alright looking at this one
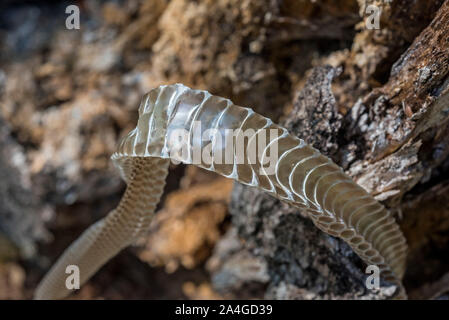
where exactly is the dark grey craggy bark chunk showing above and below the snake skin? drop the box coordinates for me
[206,66,394,299]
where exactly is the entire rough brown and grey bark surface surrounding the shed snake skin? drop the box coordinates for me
[0,0,449,299]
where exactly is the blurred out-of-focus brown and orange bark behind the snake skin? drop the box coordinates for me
[0,0,449,299]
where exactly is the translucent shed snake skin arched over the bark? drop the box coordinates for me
[35,84,407,299]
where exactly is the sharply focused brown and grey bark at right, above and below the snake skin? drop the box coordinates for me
[209,1,449,299]
